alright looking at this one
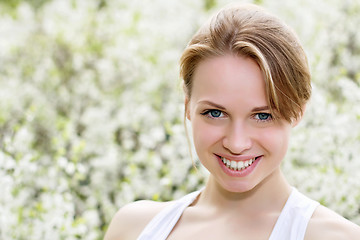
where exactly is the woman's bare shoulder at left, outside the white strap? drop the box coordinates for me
[104,200,171,240]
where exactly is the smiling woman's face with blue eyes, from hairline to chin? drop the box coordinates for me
[186,55,291,192]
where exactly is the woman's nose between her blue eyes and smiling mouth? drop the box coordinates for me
[223,122,252,155]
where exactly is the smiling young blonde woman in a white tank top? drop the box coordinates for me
[105,5,360,240]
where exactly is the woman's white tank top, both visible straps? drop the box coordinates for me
[137,188,319,240]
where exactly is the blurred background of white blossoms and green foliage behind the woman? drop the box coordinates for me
[0,0,360,240]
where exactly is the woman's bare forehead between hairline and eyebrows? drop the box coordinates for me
[191,55,267,109]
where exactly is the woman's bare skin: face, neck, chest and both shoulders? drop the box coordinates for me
[105,55,360,240]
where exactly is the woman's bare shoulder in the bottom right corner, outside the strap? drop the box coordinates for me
[305,205,360,240]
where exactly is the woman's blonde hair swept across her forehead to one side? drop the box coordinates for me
[180,4,311,122]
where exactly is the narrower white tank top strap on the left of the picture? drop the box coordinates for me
[137,190,201,240]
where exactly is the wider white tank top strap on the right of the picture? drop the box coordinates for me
[269,188,319,240]
